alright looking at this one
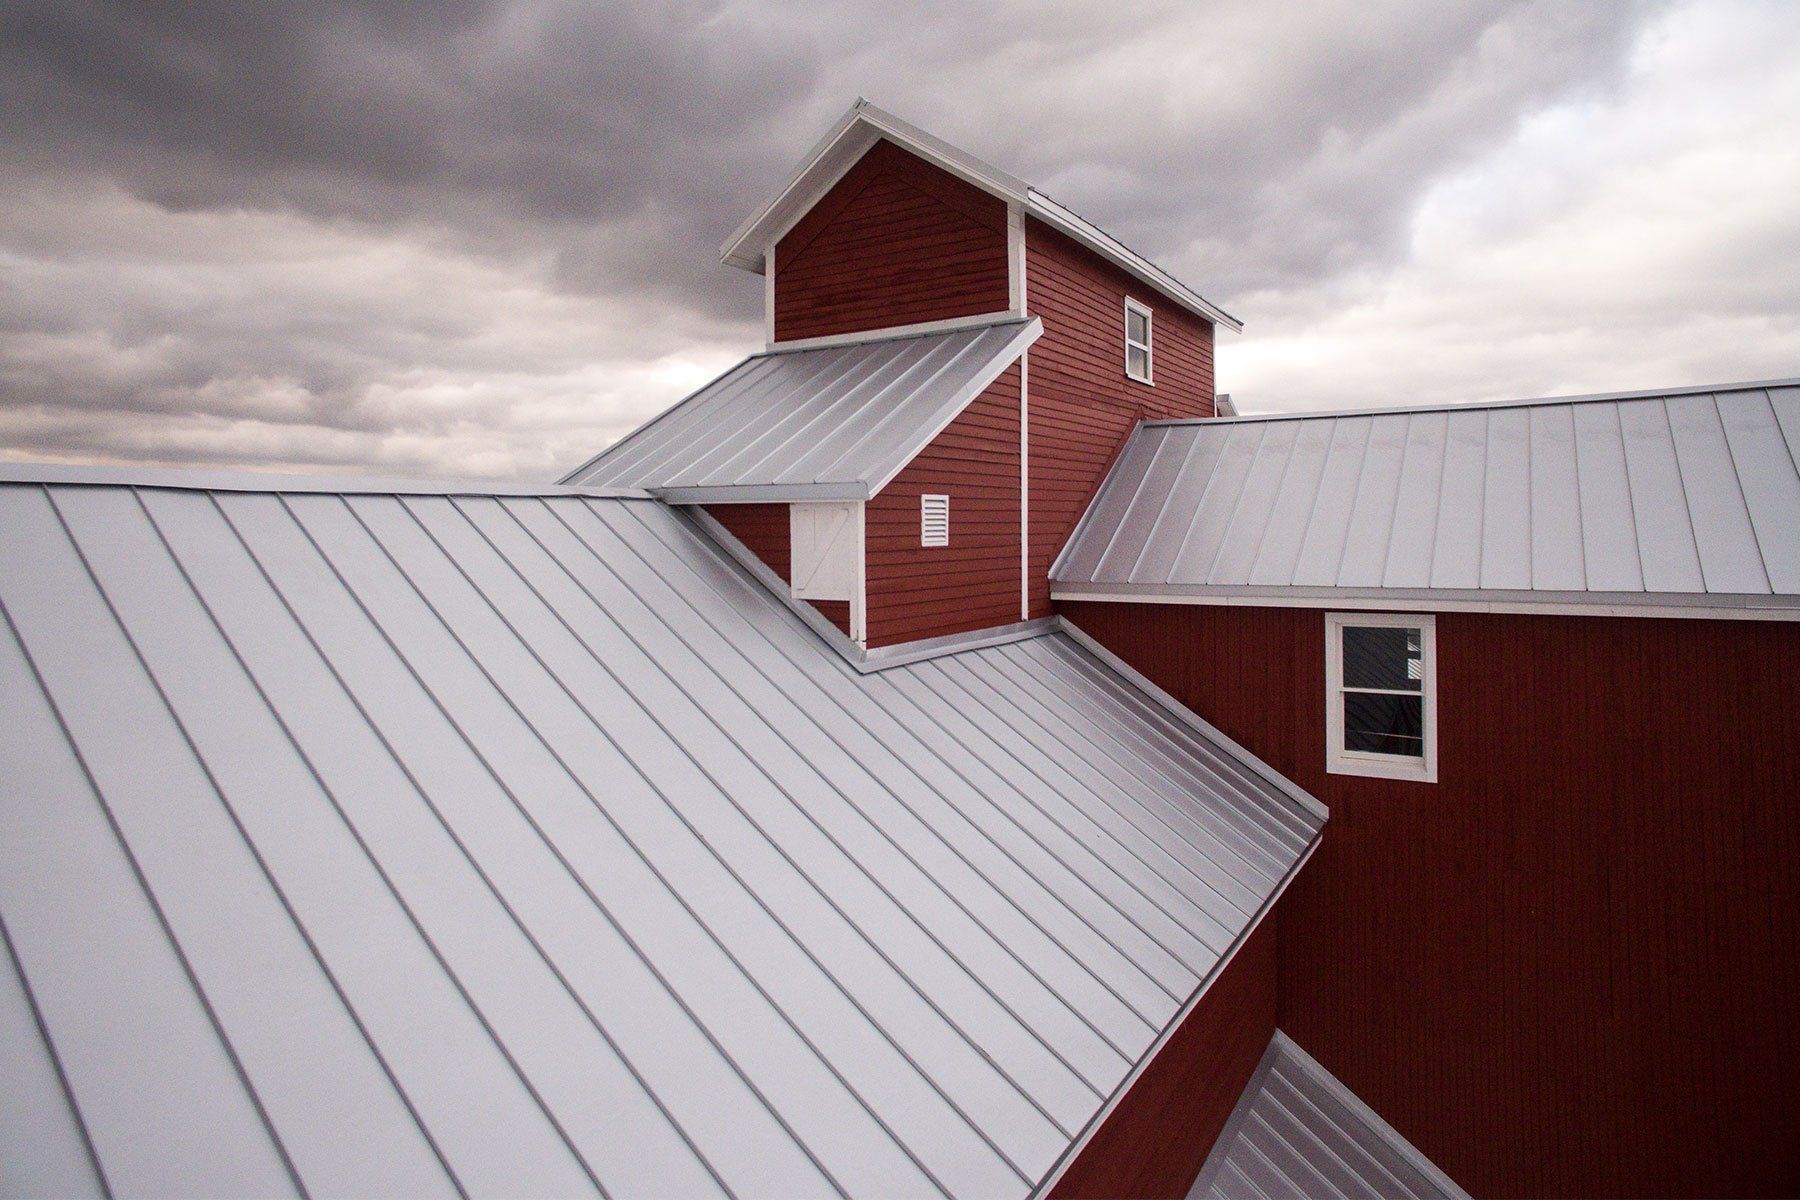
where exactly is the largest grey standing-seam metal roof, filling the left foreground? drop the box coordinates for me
[0,468,1321,1196]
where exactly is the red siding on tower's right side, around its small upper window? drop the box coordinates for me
[1024,218,1213,617]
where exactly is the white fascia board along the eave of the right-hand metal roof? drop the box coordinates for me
[1049,583,1800,621]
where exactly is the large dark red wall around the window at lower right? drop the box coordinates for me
[1060,603,1800,1196]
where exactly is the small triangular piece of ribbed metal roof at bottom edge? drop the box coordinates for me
[1188,1031,1469,1200]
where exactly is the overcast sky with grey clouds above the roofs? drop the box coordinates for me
[0,0,1800,479]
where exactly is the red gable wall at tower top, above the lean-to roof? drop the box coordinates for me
[774,140,1006,340]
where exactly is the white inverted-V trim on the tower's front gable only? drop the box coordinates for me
[718,99,1030,273]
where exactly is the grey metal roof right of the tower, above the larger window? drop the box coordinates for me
[1051,380,1800,612]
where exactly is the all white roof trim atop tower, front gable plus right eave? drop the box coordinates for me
[718,97,1244,333]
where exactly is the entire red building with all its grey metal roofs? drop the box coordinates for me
[0,103,1800,1200]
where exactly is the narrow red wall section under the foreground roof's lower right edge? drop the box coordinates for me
[1051,919,1276,1200]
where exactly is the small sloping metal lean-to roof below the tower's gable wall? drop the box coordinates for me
[563,317,1044,504]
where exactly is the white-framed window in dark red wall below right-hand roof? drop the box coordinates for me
[1325,612,1438,783]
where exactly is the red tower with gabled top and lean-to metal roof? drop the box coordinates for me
[567,101,1242,649]
